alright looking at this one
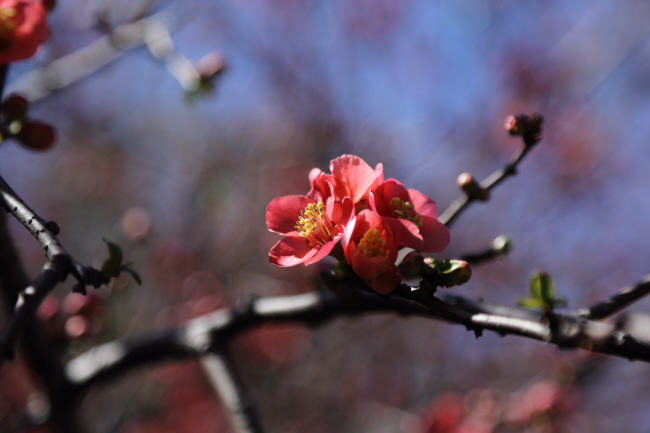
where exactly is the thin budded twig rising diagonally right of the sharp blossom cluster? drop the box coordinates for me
[438,113,544,227]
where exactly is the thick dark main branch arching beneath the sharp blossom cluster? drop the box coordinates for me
[67,274,650,388]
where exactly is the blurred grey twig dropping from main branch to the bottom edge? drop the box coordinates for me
[200,345,264,433]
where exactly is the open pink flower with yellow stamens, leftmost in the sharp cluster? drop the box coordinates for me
[266,195,354,267]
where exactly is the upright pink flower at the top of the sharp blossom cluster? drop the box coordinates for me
[307,155,384,212]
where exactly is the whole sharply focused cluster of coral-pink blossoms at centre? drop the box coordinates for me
[266,155,449,293]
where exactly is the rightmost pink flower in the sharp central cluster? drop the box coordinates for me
[370,179,449,253]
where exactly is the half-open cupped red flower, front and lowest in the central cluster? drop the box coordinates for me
[342,209,401,291]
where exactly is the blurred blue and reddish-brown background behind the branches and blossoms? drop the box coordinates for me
[0,0,650,433]
